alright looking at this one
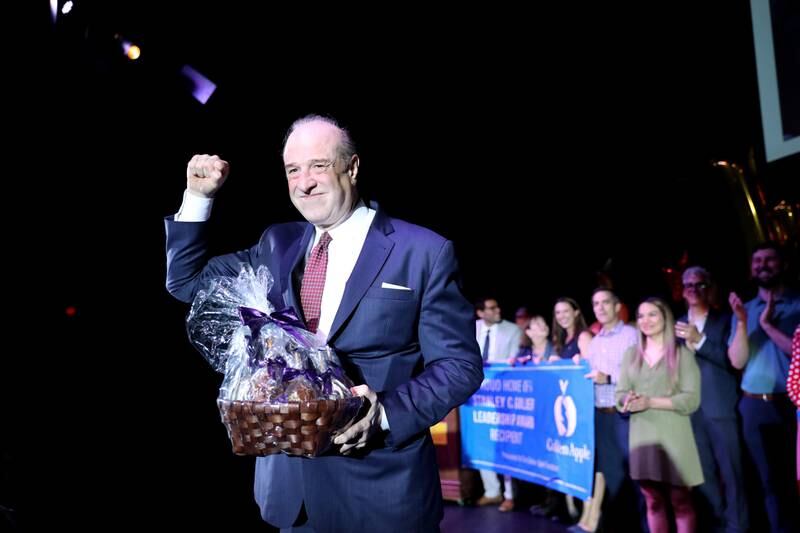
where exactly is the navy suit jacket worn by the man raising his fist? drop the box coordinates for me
[165,202,483,532]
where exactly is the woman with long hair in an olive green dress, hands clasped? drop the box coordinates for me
[616,298,703,533]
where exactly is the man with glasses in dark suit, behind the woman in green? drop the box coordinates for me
[675,266,748,532]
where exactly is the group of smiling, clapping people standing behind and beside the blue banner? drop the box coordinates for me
[476,243,800,533]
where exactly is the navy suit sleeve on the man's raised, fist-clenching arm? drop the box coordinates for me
[164,217,266,302]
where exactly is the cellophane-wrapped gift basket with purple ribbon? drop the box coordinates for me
[186,264,363,457]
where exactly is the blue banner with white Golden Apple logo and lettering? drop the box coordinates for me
[459,360,594,499]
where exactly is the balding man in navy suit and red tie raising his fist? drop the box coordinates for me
[166,116,483,533]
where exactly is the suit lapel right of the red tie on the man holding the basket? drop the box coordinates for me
[328,210,394,343]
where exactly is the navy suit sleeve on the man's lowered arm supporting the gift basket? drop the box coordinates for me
[378,241,483,448]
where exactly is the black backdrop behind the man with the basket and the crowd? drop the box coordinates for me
[0,1,800,527]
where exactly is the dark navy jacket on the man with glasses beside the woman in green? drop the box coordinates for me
[680,309,739,419]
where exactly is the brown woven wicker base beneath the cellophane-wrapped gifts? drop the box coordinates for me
[217,396,364,457]
